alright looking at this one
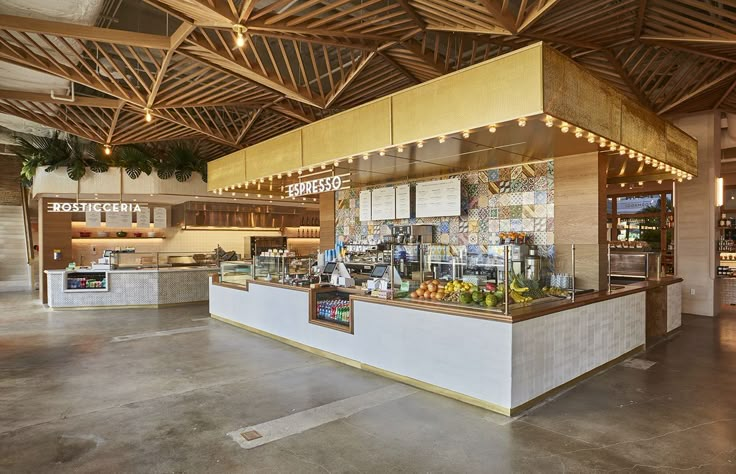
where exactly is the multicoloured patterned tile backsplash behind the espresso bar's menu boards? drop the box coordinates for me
[335,161,554,251]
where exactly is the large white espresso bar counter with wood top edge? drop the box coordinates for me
[210,275,681,415]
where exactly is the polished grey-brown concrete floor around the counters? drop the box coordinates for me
[0,294,736,473]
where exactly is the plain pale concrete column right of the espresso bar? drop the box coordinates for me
[674,112,721,316]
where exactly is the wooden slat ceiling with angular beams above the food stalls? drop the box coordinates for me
[0,0,736,158]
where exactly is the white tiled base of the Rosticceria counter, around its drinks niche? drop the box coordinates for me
[46,268,210,308]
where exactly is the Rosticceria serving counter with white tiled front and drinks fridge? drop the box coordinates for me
[45,266,218,309]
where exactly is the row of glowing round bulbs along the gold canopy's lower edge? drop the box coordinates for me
[213,115,693,194]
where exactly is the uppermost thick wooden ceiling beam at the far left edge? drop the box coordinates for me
[0,15,171,49]
